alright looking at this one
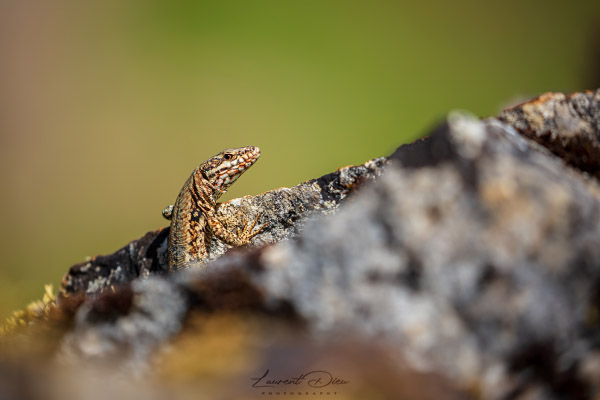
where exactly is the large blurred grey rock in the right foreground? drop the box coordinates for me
[169,111,600,398]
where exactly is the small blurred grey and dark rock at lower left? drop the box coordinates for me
[58,278,186,374]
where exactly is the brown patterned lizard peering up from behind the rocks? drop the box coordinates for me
[162,146,267,272]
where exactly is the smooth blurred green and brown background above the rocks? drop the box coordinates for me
[0,0,600,317]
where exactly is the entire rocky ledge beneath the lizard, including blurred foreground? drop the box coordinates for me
[0,90,600,399]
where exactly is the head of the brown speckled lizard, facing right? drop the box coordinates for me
[199,146,260,193]
